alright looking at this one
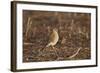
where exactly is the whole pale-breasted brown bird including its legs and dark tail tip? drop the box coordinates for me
[39,28,59,56]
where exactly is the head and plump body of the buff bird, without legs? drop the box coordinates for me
[46,28,59,48]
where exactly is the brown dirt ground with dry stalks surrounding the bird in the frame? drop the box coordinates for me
[23,10,91,62]
